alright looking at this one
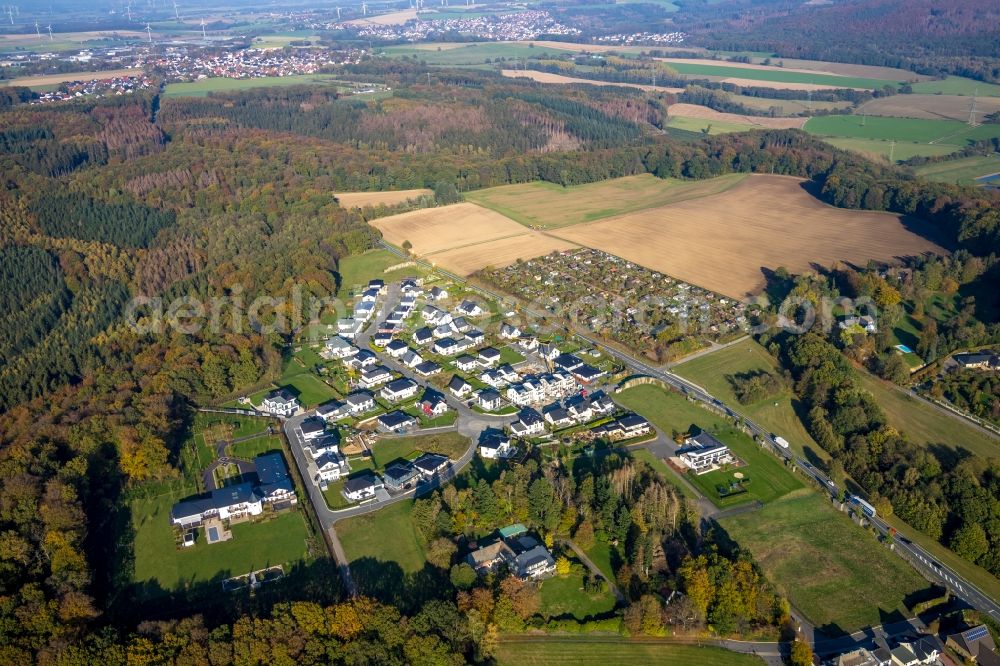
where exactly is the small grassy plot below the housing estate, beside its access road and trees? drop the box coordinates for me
[337,500,427,573]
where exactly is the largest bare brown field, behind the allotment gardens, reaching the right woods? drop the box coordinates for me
[548,175,945,298]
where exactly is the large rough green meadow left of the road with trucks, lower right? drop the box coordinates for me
[721,489,928,633]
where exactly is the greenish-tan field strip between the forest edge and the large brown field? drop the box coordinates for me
[465,174,745,229]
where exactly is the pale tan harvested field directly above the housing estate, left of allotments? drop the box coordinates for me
[372,203,576,275]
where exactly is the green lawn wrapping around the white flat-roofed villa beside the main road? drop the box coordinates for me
[616,384,802,508]
